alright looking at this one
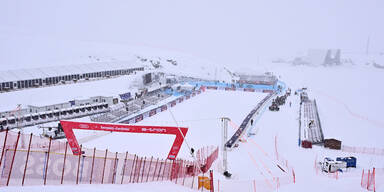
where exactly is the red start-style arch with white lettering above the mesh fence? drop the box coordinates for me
[60,121,188,160]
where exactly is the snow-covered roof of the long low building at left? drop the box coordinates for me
[0,60,142,82]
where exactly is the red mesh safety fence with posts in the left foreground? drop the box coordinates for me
[0,131,218,188]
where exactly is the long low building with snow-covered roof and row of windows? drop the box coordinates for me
[0,60,144,92]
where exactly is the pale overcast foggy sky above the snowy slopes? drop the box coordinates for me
[0,0,384,68]
